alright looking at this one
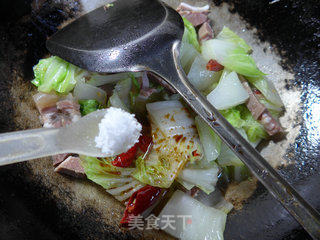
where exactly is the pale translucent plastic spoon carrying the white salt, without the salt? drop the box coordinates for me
[0,110,106,166]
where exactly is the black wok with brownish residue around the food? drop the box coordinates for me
[0,0,320,240]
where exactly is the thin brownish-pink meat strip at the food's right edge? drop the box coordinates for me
[242,81,283,136]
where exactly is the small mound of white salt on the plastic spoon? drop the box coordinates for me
[95,107,142,157]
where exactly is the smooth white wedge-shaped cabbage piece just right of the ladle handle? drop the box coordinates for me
[207,72,249,110]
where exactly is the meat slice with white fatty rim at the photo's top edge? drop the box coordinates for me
[177,2,209,27]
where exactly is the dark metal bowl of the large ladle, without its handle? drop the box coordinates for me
[47,0,184,73]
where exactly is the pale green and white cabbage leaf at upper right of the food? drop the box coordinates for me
[201,27,265,77]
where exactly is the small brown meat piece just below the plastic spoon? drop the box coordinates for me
[54,156,86,178]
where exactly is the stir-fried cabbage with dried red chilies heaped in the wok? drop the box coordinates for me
[32,1,283,235]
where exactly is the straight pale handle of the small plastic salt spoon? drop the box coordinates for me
[0,128,61,166]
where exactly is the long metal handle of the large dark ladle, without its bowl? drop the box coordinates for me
[157,43,320,239]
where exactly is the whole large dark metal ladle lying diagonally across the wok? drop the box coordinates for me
[47,0,320,236]
